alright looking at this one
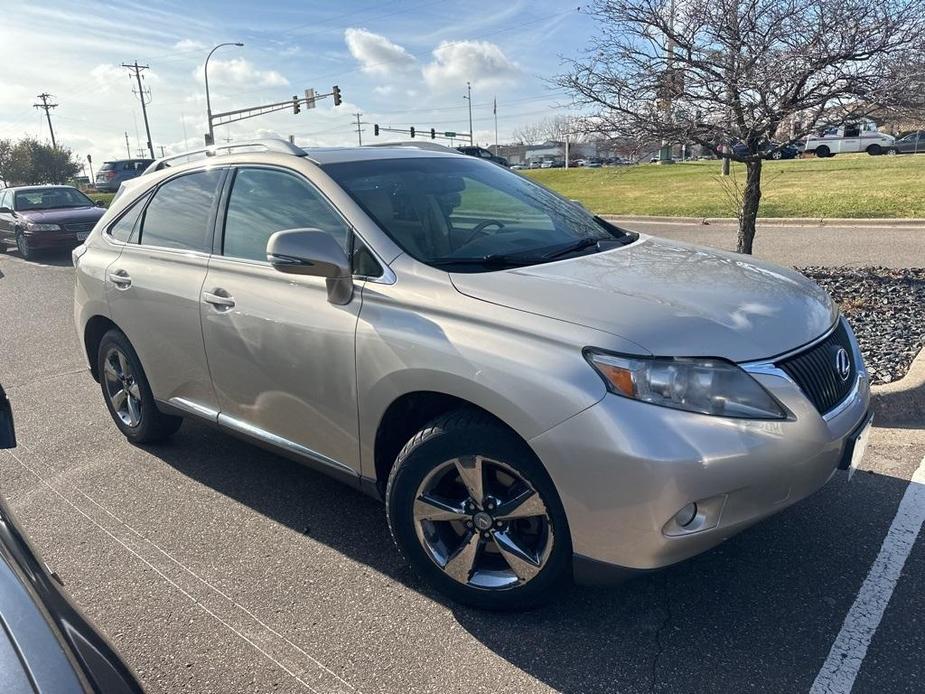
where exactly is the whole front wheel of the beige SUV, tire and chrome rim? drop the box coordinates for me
[386,408,572,610]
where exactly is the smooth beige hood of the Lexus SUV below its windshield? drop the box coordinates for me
[451,235,837,362]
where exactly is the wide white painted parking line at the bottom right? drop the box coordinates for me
[810,458,925,694]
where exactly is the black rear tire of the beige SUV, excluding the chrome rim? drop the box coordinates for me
[96,329,183,444]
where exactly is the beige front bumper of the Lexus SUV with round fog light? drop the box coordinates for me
[530,355,870,583]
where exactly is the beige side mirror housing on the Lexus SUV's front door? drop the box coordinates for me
[267,229,353,304]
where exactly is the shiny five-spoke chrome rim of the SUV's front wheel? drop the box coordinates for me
[413,455,555,589]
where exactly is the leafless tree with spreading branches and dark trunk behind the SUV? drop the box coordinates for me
[556,0,925,253]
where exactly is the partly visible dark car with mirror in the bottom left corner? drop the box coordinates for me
[0,386,142,694]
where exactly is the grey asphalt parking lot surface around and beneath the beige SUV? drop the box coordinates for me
[0,255,925,694]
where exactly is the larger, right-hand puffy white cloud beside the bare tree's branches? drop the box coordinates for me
[423,41,520,90]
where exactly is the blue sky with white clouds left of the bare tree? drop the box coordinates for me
[0,0,594,169]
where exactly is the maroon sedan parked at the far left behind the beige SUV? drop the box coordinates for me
[0,186,105,260]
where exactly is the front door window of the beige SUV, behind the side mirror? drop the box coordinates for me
[222,168,349,262]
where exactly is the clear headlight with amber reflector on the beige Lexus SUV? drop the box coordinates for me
[585,350,787,419]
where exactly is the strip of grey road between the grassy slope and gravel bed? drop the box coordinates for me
[616,219,925,268]
